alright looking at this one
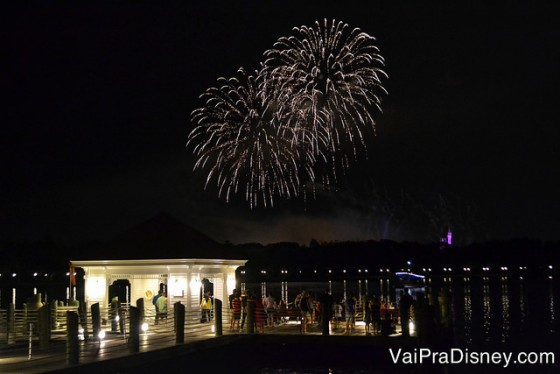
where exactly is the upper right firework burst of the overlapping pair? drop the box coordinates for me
[263,20,386,164]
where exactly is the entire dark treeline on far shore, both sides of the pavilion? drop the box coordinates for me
[0,239,560,281]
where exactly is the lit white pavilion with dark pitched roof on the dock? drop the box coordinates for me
[71,213,247,318]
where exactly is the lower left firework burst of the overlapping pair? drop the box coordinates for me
[187,69,313,208]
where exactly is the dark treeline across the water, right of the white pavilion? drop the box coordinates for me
[230,239,560,276]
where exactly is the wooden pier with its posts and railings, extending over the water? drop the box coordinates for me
[0,303,415,373]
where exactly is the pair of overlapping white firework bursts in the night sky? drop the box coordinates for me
[187,20,386,207]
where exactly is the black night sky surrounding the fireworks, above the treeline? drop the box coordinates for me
[0,1,560,243]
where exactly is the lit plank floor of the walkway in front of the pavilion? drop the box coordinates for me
[0,321,404,374]
